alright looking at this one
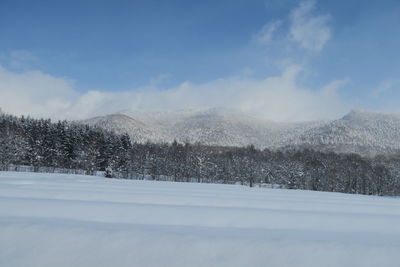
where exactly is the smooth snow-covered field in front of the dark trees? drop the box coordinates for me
[0,172,400,267]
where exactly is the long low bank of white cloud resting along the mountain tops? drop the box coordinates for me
[0,65,348,121]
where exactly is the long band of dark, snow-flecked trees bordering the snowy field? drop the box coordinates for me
[0,114,400,195]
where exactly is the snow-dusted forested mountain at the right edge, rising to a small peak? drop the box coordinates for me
[288,110,400,155]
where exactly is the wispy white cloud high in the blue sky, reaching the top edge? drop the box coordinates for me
[289,0,331,52]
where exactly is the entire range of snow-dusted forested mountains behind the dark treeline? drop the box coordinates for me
[83,108,400,155]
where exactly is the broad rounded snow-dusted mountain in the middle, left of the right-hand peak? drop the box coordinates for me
[83,108,309,147]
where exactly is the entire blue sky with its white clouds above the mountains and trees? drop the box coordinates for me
[0,0,400,121]
